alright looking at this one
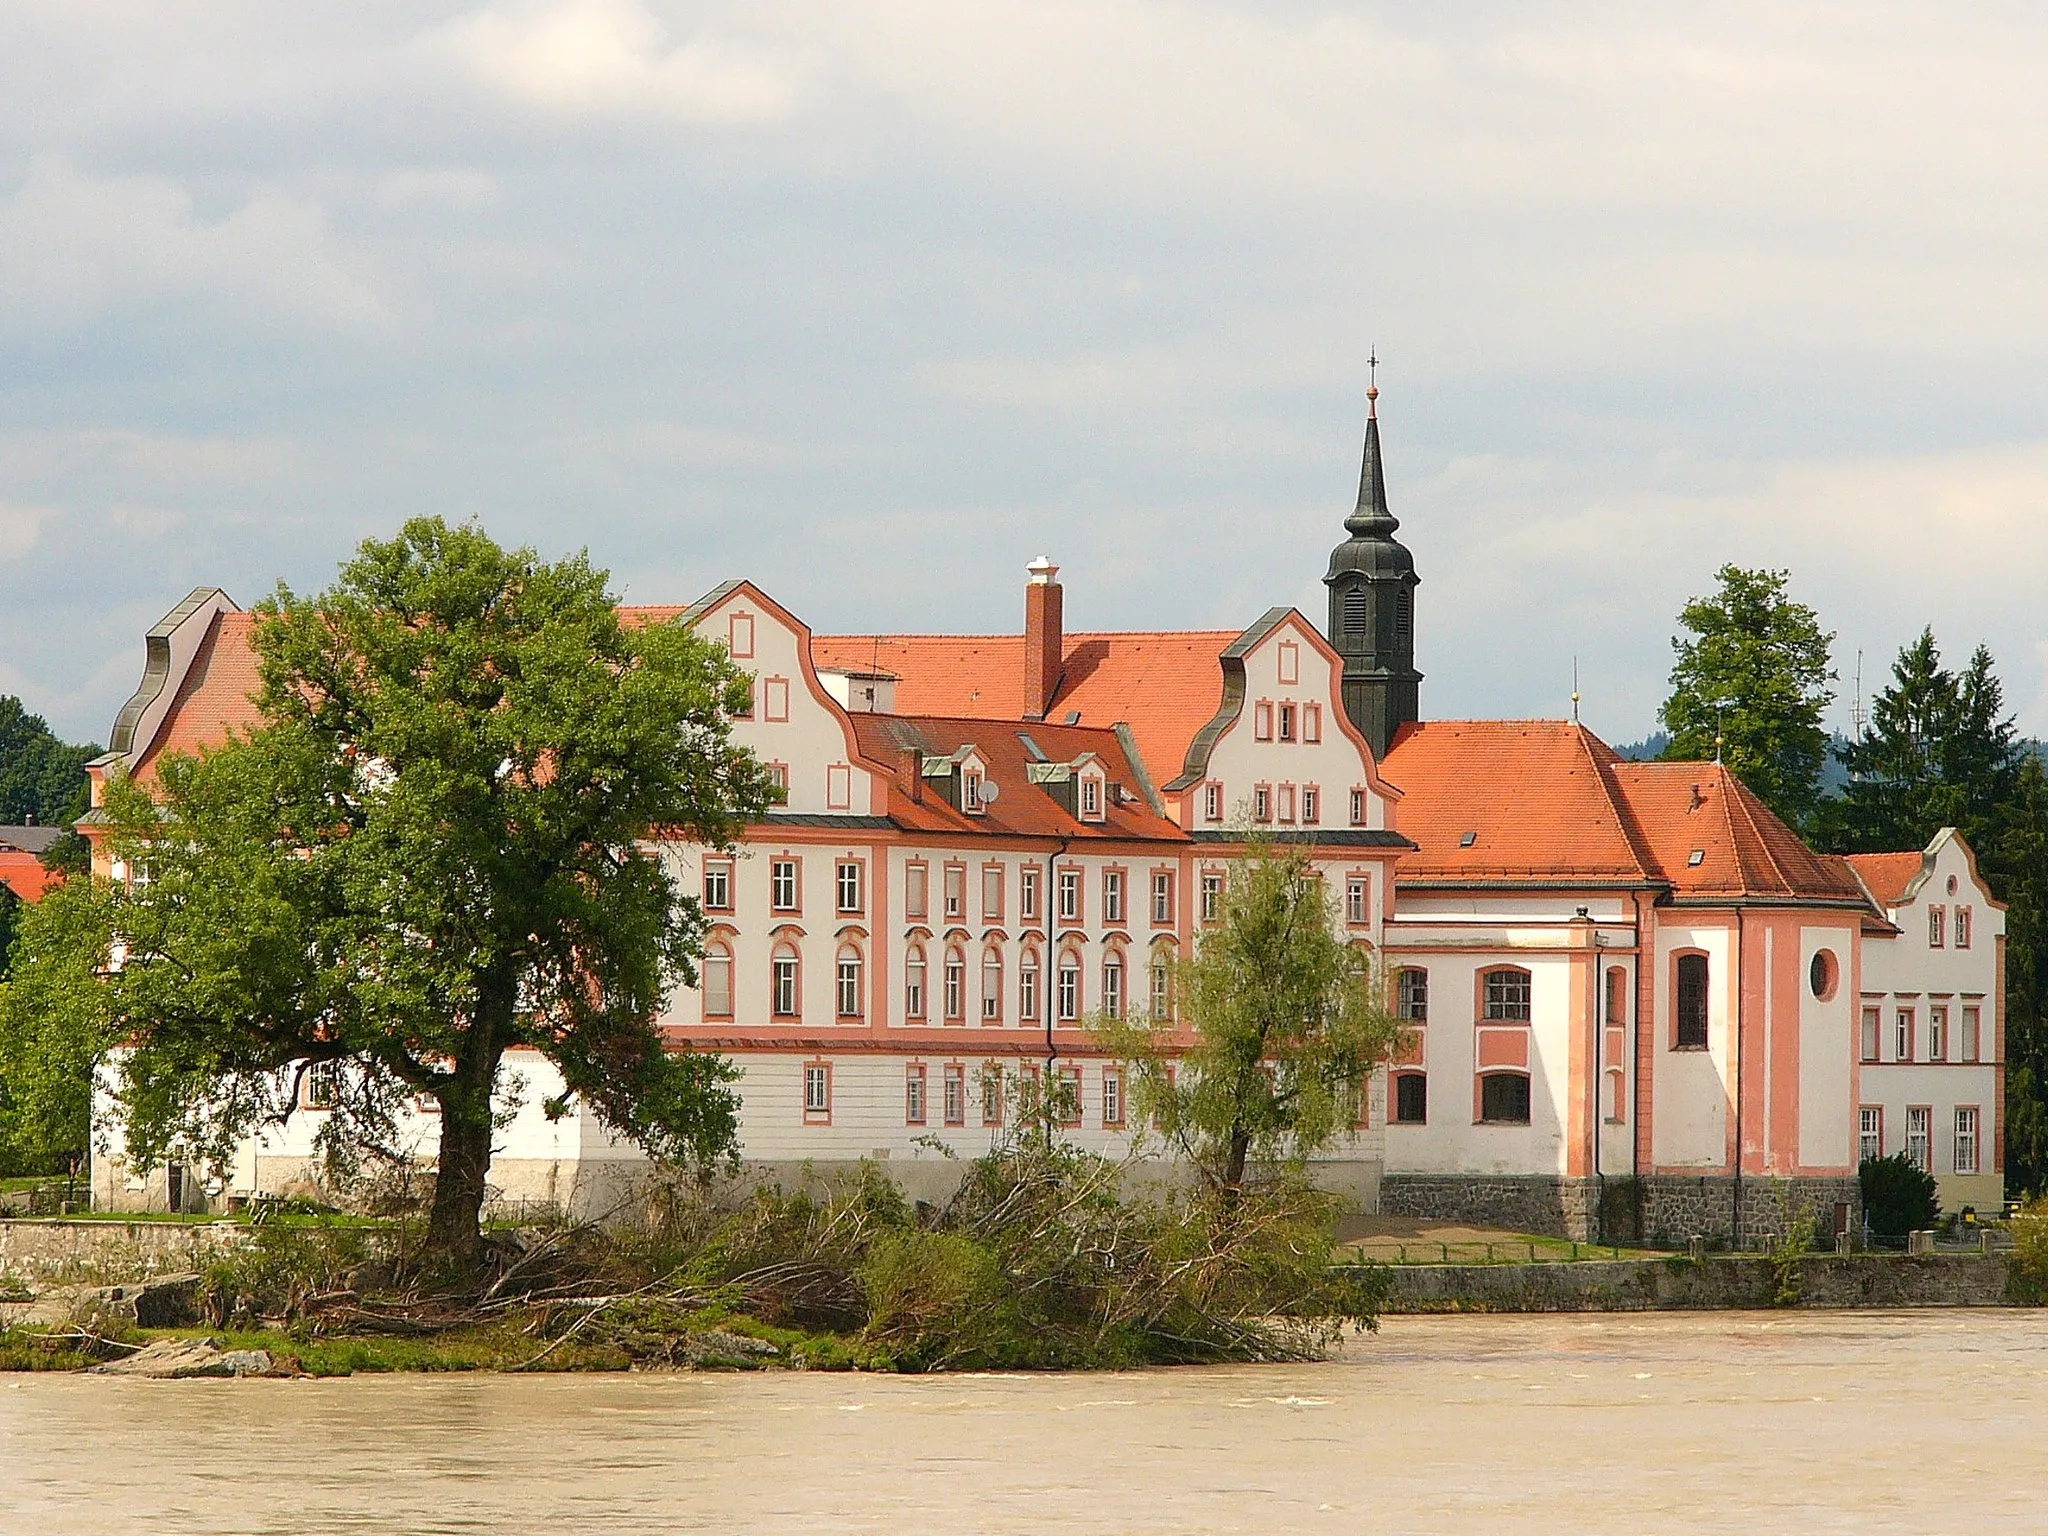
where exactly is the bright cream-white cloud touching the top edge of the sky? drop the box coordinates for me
[428,0,801,123]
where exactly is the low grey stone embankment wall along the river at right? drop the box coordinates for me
[1386,1253,2007,1313]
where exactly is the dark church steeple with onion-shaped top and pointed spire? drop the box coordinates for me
[1323,385,1421,758]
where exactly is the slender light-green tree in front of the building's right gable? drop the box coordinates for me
[1094,840,1405,1194]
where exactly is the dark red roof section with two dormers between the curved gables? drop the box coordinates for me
[850,713,1188,844]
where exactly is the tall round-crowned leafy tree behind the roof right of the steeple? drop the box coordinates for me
[1661,565,1835,825]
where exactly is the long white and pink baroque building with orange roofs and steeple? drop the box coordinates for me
[92,412,2003,1241]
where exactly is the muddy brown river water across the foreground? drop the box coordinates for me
[0,1311,2048,1536]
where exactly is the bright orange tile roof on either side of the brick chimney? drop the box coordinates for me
[811,629,1237,784]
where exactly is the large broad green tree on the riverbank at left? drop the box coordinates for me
[14,520,774,1268]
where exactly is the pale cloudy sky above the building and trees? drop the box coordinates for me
[0,0,2048,741]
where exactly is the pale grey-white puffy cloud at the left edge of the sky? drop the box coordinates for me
[0,154,383,334]
